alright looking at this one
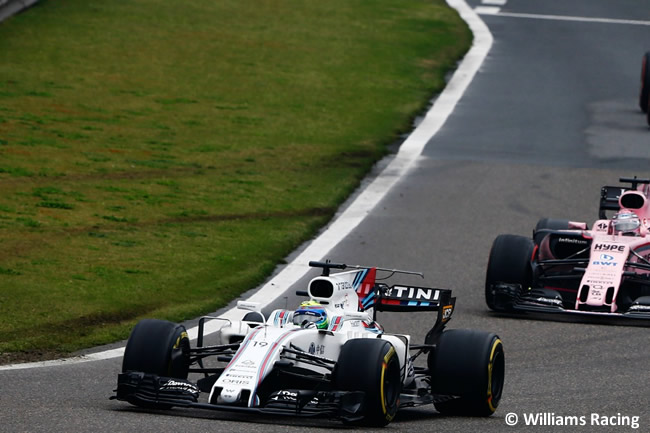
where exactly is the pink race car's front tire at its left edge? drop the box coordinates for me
[485,235,534,311]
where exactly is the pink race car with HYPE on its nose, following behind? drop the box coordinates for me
[485,177,650,319]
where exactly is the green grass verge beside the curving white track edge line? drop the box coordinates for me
[0,0,471,360]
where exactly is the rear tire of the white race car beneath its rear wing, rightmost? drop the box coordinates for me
[428,329,505,416]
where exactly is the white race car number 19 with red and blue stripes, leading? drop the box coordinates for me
[111,262,505,426]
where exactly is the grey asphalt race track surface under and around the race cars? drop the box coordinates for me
[0,0,650,433]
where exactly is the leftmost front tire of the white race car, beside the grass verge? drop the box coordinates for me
[122,319,190,379]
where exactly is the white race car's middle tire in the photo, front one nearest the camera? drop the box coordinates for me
[333,338,402,427]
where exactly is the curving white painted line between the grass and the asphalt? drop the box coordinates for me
[0,0,493,371]
